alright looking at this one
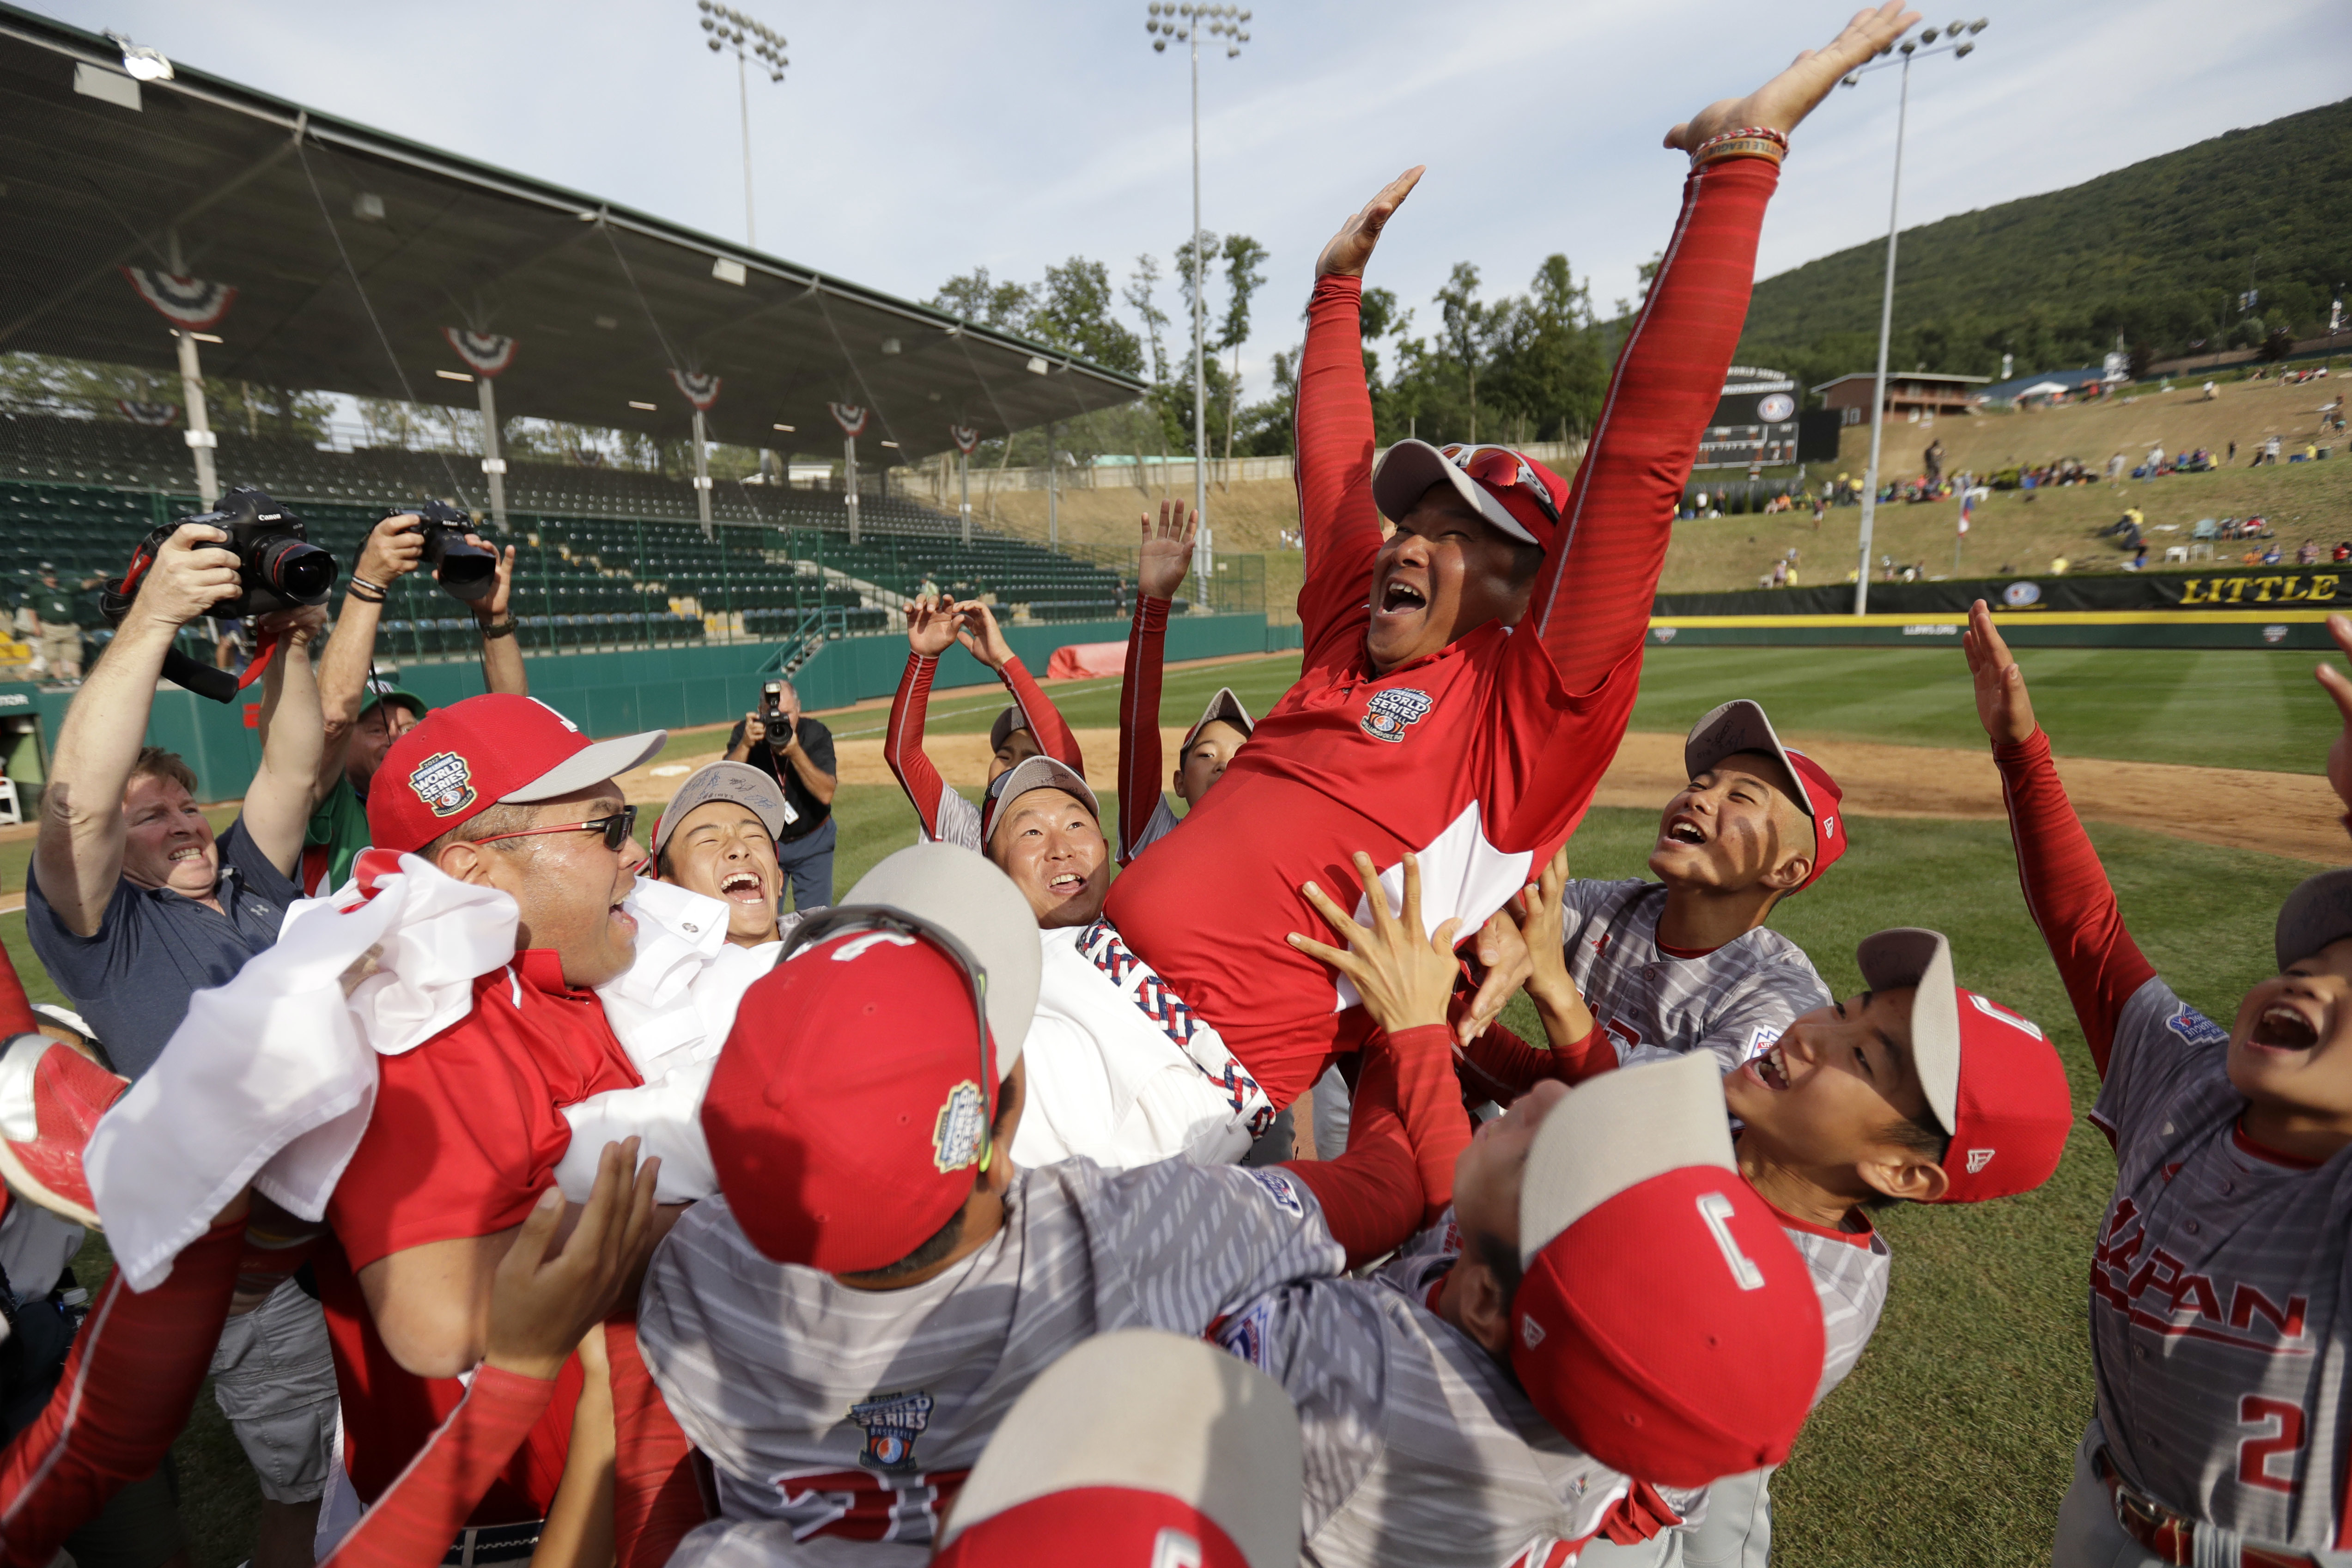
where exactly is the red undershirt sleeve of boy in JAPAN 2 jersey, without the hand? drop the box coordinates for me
[1992,729,2157,1077]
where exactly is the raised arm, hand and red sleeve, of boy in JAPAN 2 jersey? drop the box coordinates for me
[1962,600,2157,1077]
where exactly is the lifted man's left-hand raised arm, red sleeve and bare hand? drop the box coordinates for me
[1296,167,1421,668]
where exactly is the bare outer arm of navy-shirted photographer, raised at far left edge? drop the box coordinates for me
[33,522,240,936]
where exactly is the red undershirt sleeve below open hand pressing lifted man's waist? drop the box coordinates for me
[1282,1022,1470,1270]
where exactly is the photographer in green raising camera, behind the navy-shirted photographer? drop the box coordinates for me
[301,512,532,893]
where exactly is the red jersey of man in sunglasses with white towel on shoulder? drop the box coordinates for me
[317,948,642,1523]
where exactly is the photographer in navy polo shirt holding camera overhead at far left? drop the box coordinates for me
[24,524,336,1568]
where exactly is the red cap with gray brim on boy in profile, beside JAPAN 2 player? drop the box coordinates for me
[1854,926,2074,1203]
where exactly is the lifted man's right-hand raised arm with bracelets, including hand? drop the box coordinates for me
[1522,0,1917,703]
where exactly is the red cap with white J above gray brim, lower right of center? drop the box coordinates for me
[1510,1051,1825,1486]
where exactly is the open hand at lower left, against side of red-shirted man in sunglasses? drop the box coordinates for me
[485,1138,661,1378]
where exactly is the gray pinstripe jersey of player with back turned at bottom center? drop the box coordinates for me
[638,1159,1345,1544]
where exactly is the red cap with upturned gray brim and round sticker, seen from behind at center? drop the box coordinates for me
[701,844,1042,1274]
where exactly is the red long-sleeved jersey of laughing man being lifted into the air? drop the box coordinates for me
[1108,160,1778,1105]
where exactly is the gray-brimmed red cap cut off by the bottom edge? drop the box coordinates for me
[931,1328,1303,1568]
